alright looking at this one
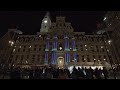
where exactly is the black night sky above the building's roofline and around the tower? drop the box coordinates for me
[0,11,106,36]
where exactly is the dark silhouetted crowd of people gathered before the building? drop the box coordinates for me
[0,66,117,79]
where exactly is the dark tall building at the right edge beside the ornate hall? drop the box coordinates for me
[104,11,120,64]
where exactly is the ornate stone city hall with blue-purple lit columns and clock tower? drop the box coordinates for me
[0,13,115,68]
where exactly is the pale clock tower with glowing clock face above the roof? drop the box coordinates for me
[40,12,51,32]
